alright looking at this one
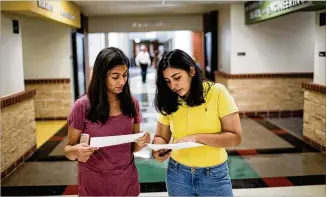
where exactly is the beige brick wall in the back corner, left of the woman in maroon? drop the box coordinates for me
[25,83,72,118]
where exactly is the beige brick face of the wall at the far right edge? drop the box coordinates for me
[303,90,326,146]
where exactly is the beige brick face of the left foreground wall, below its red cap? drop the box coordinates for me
[0,98,36,172]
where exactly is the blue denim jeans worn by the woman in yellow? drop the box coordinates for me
[166,158,233,196]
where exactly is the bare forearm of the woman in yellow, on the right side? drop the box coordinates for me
[196,131,242,148]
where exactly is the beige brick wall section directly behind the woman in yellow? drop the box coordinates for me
[216,76,312,112]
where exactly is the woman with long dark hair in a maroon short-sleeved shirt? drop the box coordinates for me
[65,47,150,196]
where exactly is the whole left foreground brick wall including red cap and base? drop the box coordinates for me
[0,90,36,180]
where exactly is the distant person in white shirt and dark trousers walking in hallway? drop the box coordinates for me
[135,45,151,83]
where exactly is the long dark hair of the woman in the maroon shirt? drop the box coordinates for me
[87,47,136,124]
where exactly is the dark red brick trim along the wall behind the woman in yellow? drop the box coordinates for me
[215,71,313,79]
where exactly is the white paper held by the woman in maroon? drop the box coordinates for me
[90,132,145,148]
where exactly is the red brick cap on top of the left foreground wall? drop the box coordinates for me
[0,90,36,109]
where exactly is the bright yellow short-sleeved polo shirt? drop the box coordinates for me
[158,83,238,167]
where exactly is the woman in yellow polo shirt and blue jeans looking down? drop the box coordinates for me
[152,49,242,196]
